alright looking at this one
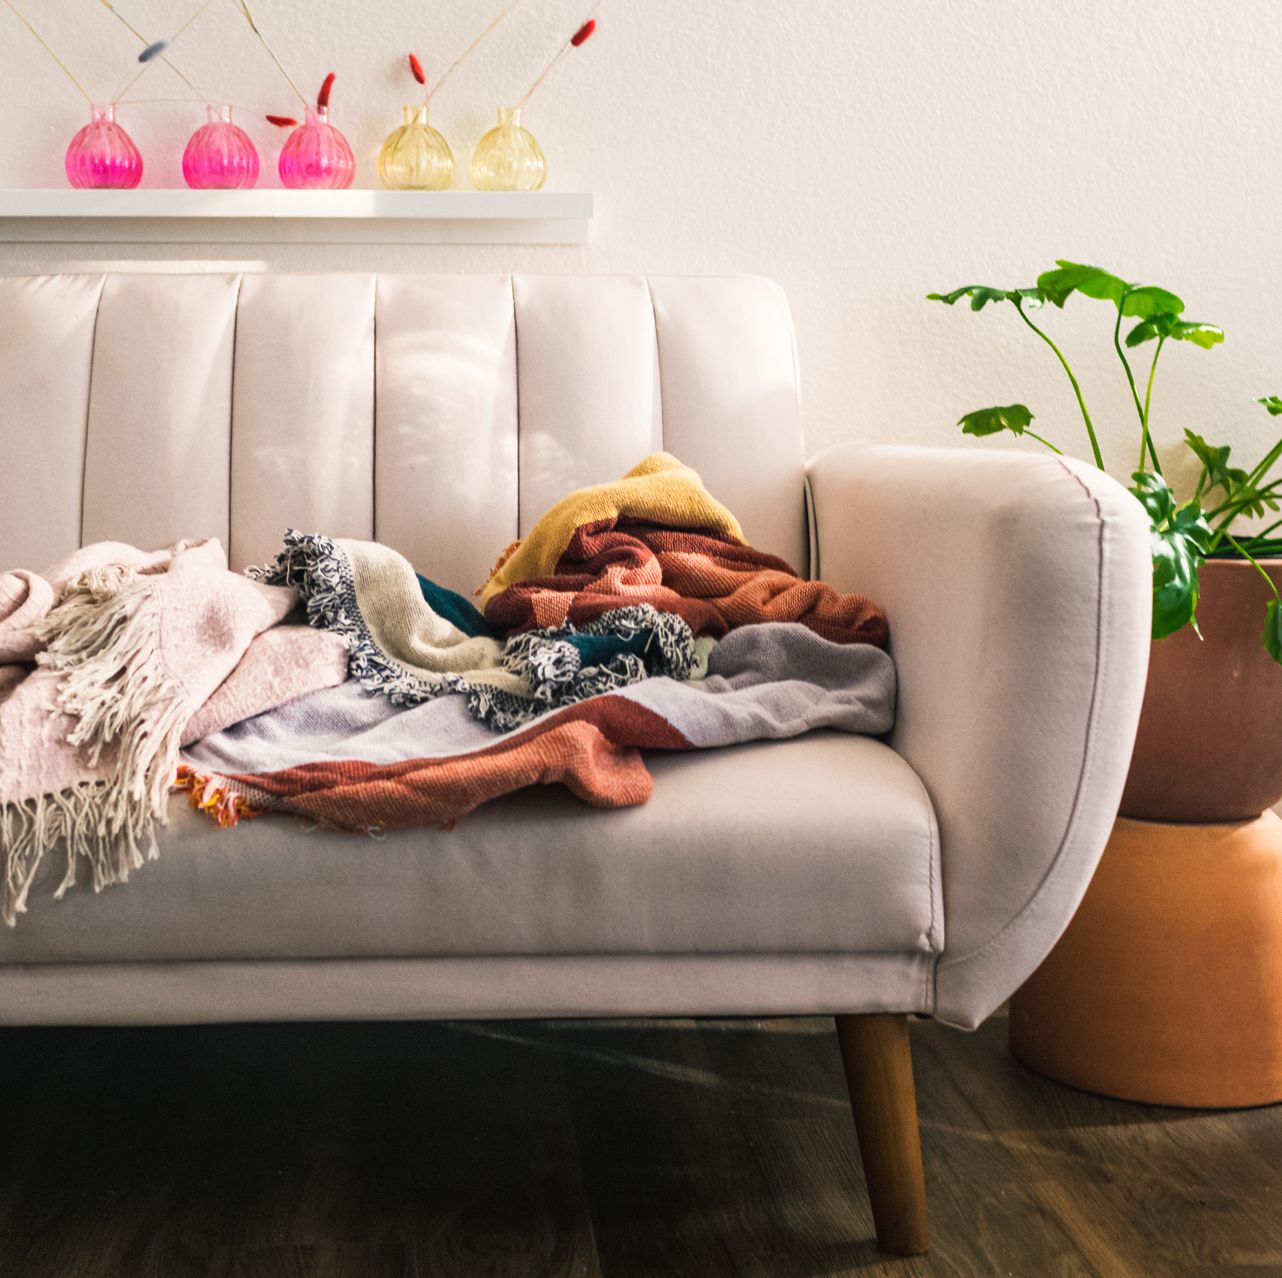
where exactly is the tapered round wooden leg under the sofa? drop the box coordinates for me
[837,1015,927,1256]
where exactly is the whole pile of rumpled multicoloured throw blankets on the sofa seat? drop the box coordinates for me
[0,454,895,925]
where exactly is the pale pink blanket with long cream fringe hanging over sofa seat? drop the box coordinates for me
[0,541,346,927]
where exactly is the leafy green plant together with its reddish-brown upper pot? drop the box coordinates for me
[929,260,1282,822]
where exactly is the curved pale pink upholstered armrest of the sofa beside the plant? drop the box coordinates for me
[808,445,1151,1027]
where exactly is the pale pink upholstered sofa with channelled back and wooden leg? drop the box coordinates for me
[0,274,1149,1251]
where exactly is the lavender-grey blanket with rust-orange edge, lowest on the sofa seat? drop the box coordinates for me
[183,623,895,829]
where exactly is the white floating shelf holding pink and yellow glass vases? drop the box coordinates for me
[0,188,592,244]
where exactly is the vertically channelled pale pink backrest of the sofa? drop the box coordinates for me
[0,273,808,590]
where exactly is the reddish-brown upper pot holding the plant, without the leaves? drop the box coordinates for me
[1122,559,1282,822]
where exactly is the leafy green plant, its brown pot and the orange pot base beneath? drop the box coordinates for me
[931,261,1282,1108]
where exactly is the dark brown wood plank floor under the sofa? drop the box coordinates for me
[0,1020,1282,1278]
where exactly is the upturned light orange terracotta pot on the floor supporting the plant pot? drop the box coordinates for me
[1010,813,1282,1109]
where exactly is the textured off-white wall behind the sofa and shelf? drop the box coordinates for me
[0,0,1282,484]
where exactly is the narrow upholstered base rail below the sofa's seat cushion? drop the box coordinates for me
[0,952,935,1025]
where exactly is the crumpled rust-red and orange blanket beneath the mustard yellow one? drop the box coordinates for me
[485,518,888,647]
